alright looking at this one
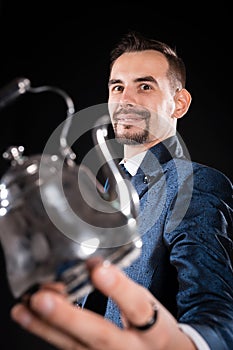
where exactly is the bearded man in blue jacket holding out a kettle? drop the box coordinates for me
[12,33,233,350]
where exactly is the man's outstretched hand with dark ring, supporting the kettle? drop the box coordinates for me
[11,263,195,350]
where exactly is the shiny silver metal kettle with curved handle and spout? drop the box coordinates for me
[0,78,142,302]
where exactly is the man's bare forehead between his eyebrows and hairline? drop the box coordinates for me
[110,50,169,80]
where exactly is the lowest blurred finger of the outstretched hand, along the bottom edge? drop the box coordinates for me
[11,304,87,350]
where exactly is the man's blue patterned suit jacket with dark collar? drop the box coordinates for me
[105,136,233,350]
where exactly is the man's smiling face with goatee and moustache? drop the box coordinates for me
[108,50,176,144]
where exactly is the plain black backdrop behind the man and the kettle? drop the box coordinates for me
[0,0,233,350]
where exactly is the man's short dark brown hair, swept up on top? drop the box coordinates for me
[110,31,186,88]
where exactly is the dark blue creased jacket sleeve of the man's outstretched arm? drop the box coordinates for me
[164,166,233,350]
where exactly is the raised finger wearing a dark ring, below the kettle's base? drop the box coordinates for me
[91,263,194,349]
